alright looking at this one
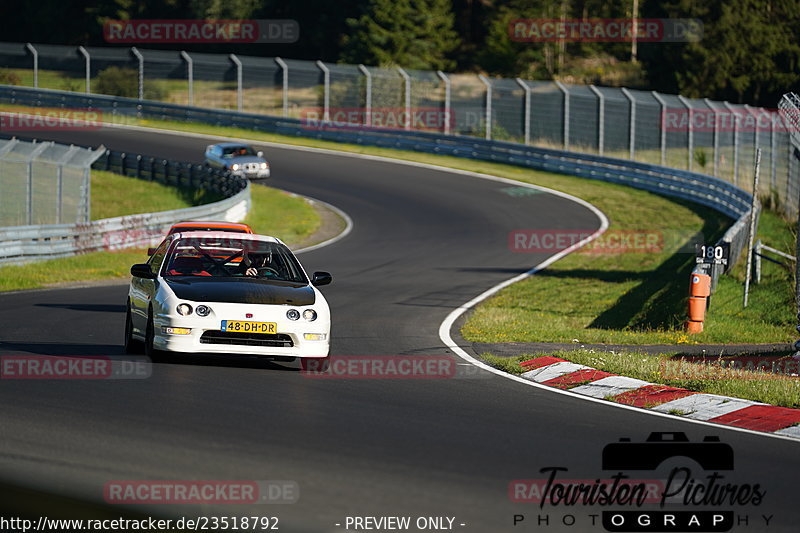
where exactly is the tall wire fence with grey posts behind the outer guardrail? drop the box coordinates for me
[0,43,800,216]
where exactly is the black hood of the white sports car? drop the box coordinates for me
[166,276,316,306]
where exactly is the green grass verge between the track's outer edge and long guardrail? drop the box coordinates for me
[0,104,794,344]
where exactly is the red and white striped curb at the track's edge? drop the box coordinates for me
[520,356,800,439]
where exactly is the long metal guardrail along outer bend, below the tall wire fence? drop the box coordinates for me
[0,86,752,272]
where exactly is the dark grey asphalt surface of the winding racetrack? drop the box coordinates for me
[0,123,800,532]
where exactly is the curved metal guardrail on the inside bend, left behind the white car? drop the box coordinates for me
[0,137,250,264]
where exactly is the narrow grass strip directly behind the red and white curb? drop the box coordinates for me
[480,350,800,408]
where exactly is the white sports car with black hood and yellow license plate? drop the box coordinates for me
[125,231,331,368]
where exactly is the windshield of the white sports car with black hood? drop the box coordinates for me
[163,237,308,283]
